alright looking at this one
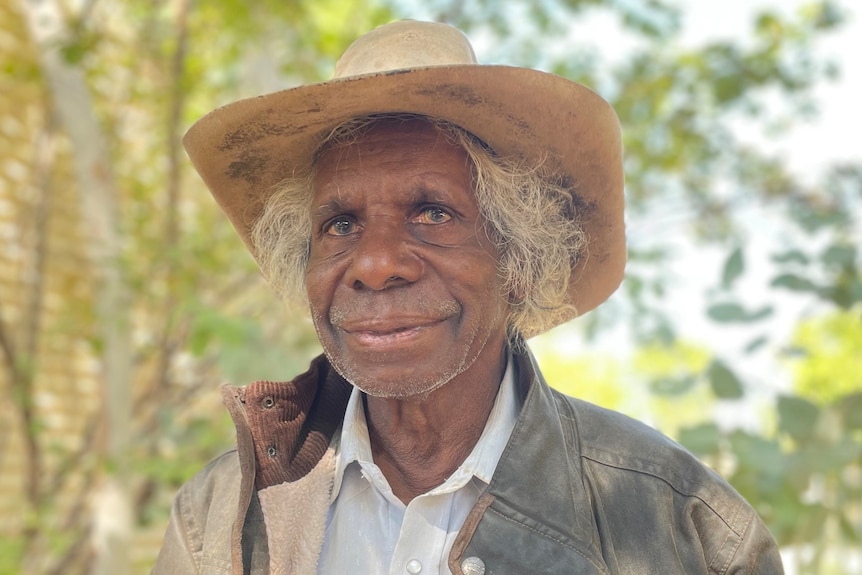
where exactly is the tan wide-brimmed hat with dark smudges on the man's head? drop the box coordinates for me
[183,21,626,328]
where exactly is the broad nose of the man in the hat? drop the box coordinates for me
[344,221,423,291]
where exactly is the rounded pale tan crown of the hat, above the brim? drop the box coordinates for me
[333,20,478,78]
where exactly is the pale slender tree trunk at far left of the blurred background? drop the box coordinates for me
[21,0,132,575]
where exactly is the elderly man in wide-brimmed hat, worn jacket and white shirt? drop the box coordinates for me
[155,22,781,575]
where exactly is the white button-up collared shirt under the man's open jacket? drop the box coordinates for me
[317,354,521,575]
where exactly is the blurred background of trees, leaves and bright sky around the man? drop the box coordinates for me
[0,0,862,575]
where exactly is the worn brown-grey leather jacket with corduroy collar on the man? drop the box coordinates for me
[153,353,783,575]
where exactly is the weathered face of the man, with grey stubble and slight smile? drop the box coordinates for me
[305,121,508,399]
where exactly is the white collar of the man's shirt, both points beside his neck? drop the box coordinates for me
[331,352,521,501]
